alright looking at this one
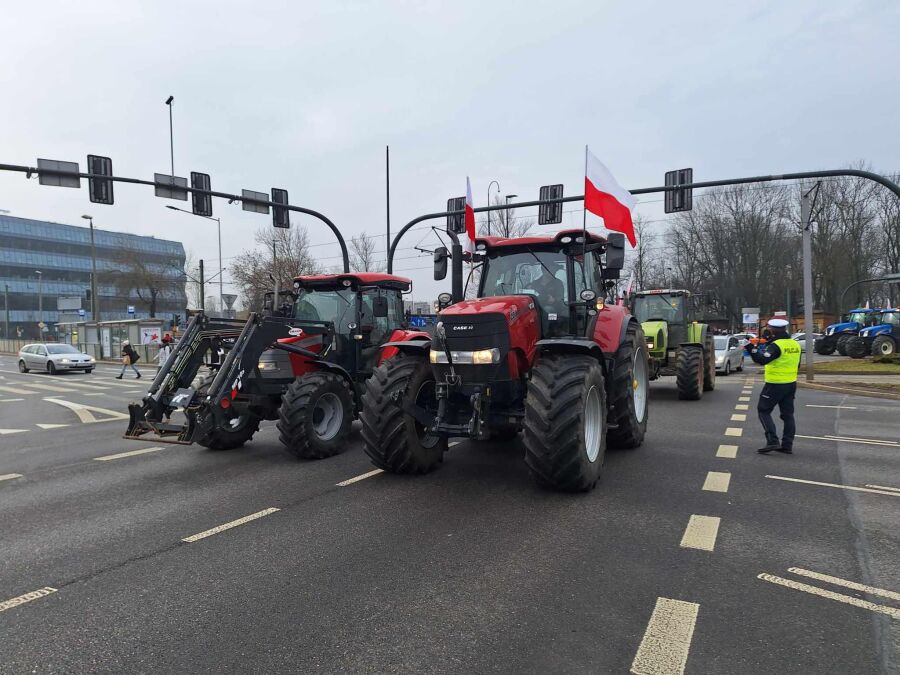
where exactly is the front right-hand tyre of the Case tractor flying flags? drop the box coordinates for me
[524,354,607,492]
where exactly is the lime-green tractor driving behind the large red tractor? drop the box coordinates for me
[631,289,716,401]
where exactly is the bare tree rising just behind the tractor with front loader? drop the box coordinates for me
[229,225,319,310]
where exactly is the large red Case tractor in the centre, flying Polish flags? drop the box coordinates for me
[360,230,649,491]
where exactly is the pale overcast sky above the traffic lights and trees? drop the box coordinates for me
[0,0,900,298]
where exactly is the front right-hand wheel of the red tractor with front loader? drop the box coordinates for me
[276,371,353,459]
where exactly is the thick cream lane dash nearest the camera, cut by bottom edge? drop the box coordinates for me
[631,598,700,675]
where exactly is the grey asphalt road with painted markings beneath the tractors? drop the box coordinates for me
[0,356,900,673]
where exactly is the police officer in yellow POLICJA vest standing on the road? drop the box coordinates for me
[750,319,800,455]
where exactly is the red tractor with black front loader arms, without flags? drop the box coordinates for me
[125,273,429,459]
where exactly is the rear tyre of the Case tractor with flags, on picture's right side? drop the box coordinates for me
[606,323,650,448]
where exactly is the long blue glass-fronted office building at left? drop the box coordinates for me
[0,214,187,339]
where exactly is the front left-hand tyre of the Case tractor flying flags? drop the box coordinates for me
[359,353,447,474]
